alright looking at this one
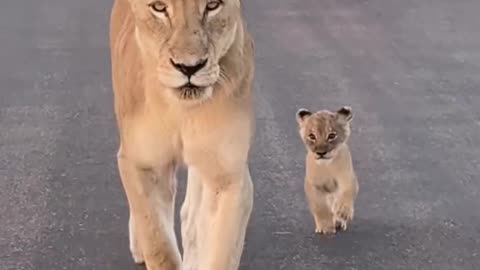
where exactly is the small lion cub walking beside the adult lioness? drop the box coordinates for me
[296,106,359,234]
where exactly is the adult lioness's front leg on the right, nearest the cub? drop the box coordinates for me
[198,167,253,270]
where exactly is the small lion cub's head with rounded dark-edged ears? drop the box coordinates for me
[296,106,353,159]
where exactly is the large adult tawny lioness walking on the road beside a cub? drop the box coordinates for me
[110,0,255,270]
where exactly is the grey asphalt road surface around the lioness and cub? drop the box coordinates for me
[0,0,480,270]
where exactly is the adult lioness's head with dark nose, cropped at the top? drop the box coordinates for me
[128,0,241,99]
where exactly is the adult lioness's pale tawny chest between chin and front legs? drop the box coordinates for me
[123,98,253,169]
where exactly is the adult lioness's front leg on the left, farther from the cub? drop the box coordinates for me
[118,154,180,270]
